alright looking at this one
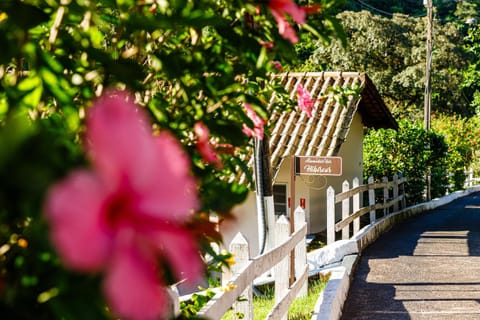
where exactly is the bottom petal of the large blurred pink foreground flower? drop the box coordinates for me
[104,247,167,320]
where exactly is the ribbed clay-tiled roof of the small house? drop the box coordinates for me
[238,72,398,184]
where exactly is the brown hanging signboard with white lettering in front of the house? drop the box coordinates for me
[295,156,342,176]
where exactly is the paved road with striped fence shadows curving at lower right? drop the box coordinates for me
[342,193,480,320]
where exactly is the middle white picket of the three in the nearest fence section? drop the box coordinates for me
[273,216,290,320]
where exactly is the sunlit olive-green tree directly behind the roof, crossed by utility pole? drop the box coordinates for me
[300,11,471,119]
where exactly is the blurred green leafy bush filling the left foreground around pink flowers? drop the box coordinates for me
[0,0,339,319]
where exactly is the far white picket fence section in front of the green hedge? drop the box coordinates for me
[327,175,406,244]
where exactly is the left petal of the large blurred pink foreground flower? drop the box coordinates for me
[45,171,111,271]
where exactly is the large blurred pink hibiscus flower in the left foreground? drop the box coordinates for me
[46,91,203,319]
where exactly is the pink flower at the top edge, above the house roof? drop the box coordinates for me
[268,0,306,43]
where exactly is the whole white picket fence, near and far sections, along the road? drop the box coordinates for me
[175,172,480,320]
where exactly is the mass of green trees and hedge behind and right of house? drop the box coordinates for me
[302,0,480,201]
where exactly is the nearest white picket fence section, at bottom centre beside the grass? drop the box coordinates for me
[193,207,308,320]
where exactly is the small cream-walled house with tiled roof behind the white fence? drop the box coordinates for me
[221,72,398,256]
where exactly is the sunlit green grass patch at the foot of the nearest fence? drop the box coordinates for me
[222,274,330,320]
